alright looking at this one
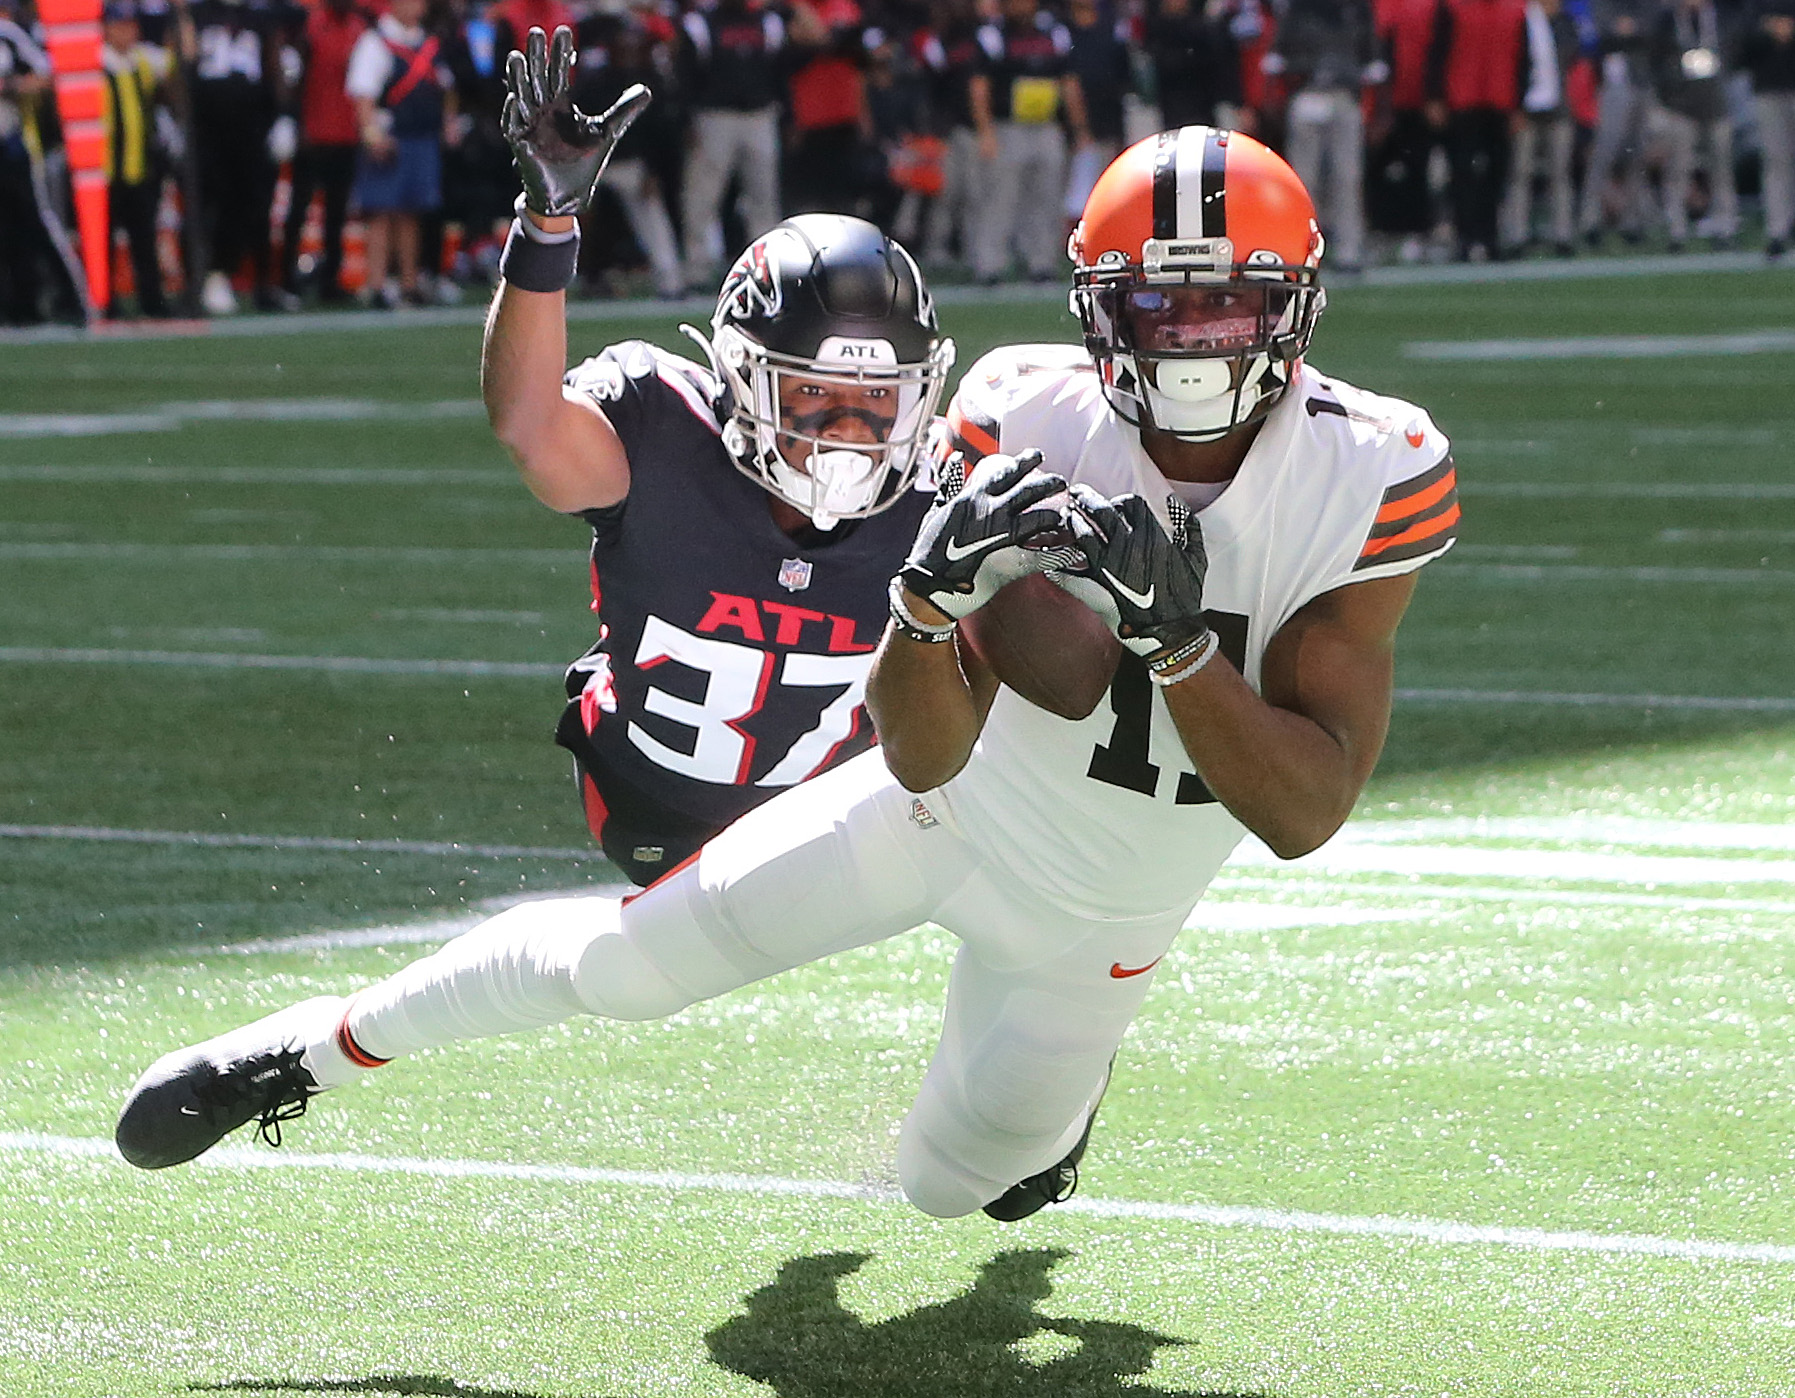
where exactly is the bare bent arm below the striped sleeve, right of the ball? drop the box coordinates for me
[1165,572,1416,860]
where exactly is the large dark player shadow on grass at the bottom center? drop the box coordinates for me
[704,1247,1255,1398]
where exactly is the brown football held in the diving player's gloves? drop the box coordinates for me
[960,572,1122,718]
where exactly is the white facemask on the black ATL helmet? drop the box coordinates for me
[689,323,953,529]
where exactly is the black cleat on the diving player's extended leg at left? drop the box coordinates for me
[113,996,348,1170]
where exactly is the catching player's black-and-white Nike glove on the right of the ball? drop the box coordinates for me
[1048,485,1210,659]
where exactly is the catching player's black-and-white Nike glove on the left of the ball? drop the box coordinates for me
[898,450,1066,621]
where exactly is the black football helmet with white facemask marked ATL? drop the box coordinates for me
[680,214,953,529]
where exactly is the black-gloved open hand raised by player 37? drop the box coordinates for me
[499,25,650,215]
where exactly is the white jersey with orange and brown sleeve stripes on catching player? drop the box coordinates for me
[928,345,1459,917]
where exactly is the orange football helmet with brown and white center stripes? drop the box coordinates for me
[1068,126,1327,441]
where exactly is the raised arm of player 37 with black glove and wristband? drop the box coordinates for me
[479,27,648,511]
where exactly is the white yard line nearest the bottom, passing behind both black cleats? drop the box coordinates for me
[0,1131,1795,1265]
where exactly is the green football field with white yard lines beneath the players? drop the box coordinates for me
[0,271,1795,1398]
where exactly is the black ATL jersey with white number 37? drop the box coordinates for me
[556,341,930,874]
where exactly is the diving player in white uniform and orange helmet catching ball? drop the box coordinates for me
[117,127,1458,1219]
